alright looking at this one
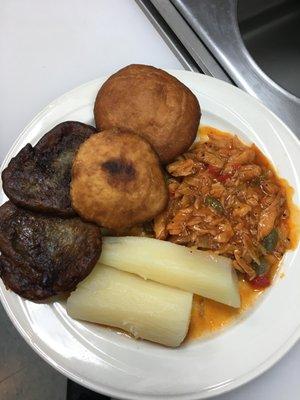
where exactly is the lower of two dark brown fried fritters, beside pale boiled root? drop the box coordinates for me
[0,202,101,300]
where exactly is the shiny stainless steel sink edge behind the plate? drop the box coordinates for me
[137,0,300,136]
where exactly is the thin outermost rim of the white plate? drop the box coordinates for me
[0,69,300,400]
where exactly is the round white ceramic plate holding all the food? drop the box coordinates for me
[0,71,300,400]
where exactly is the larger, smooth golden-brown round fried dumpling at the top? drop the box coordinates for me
[94,65,201,163]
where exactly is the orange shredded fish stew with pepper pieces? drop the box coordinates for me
[154,127,290,289]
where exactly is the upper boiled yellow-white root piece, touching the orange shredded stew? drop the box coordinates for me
[100,236,240,308]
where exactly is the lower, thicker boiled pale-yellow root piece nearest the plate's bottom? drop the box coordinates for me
[67,264,193,347]
